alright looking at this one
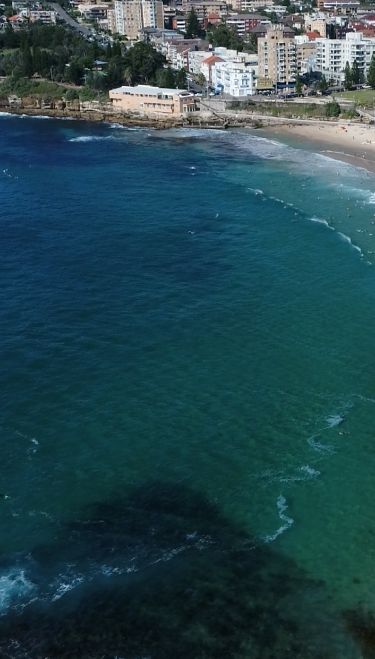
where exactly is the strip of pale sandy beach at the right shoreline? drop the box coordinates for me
[267,122,375,173]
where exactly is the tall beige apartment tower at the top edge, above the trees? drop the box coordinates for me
[114,0,164,39]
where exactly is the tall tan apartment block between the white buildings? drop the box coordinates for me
[258,25,297,88]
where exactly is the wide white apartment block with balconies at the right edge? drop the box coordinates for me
[315,32,375,84]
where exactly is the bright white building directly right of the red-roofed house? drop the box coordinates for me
[212,62,255,97]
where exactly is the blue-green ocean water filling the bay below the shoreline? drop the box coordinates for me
[0,115,375,659]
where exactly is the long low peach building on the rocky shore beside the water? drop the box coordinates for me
[109,85,197,117]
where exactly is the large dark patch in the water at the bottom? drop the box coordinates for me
[0,483,360,659]
